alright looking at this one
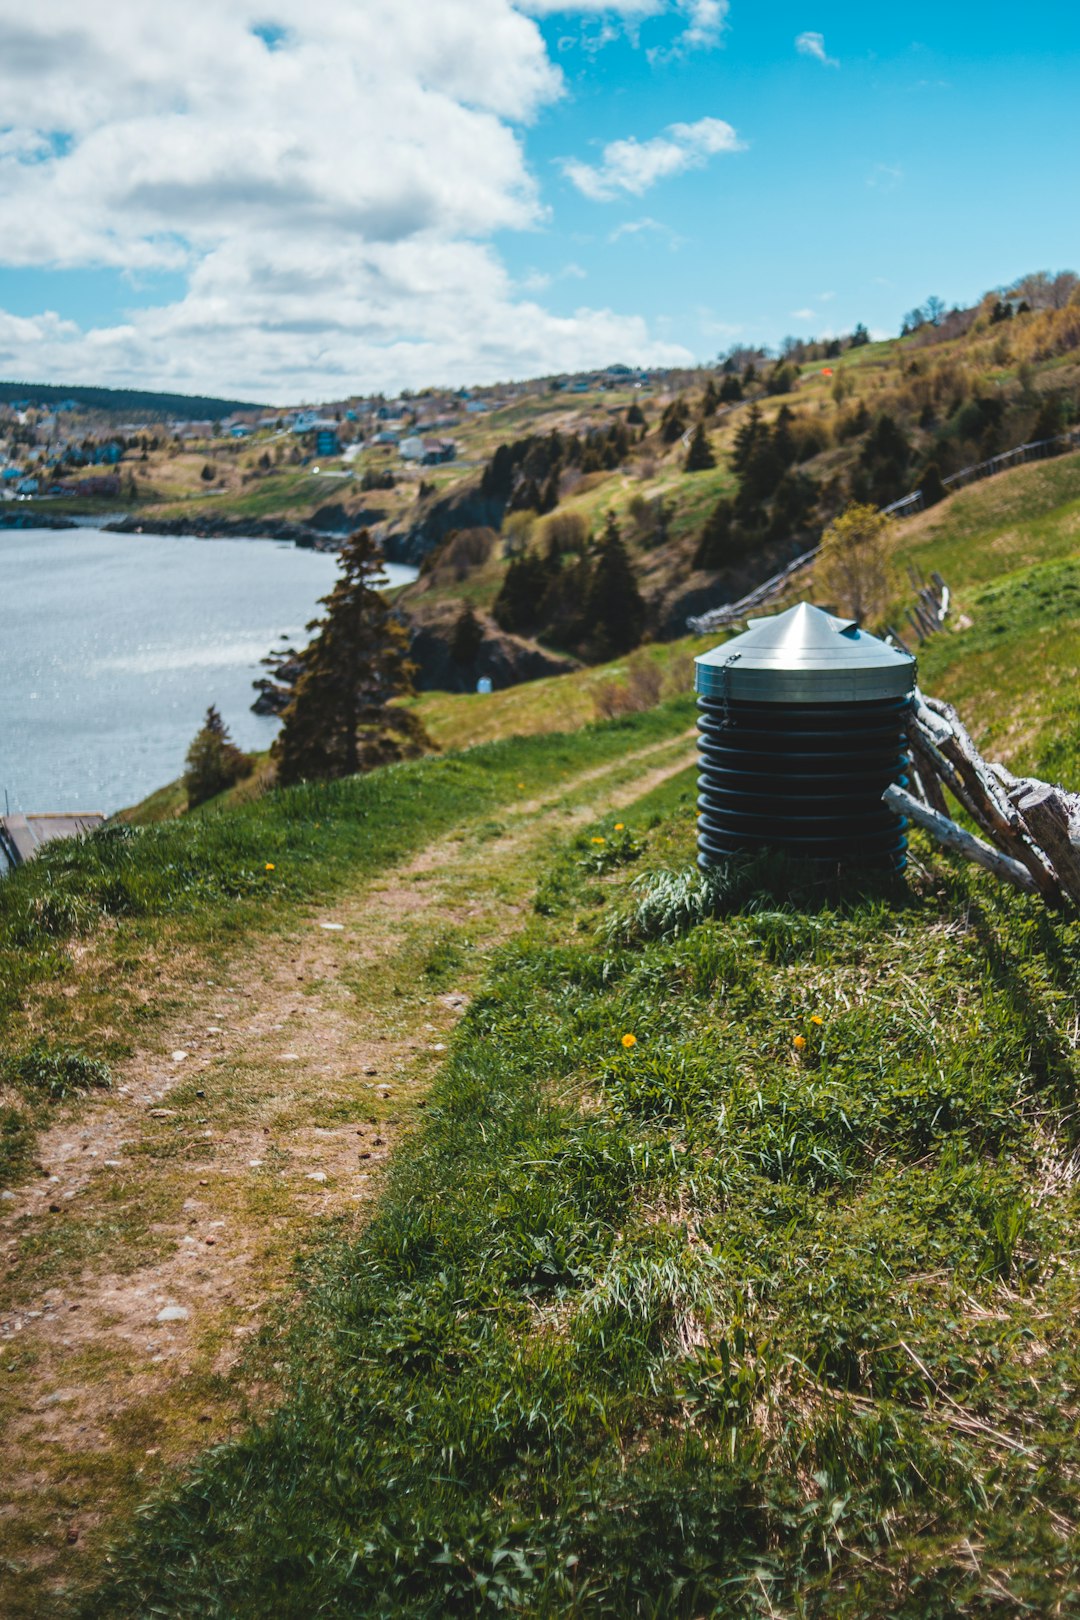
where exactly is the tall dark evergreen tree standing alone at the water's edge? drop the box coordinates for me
[272,530,427,784]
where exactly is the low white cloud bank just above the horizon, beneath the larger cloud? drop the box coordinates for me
[0,238,690,403]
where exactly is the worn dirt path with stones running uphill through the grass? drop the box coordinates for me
[0,737,691,1617]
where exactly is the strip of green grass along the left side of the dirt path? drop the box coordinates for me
[0,697,691,1181]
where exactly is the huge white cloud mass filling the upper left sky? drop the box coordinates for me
[0,0,693,400]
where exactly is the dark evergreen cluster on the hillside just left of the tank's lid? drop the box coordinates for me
[492,512,646,663]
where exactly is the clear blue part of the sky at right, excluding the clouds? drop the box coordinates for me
[511,0,1080,355]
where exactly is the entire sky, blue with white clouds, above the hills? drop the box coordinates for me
[0,0,1080,400]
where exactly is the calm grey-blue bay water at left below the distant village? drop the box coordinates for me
[0,528,416,812]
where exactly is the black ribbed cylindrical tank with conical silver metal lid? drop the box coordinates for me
[695,603,915,872]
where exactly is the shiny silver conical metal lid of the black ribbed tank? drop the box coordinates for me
[695,603,915,703]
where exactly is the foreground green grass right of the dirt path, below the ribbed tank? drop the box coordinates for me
[79,797,1080,1620]
